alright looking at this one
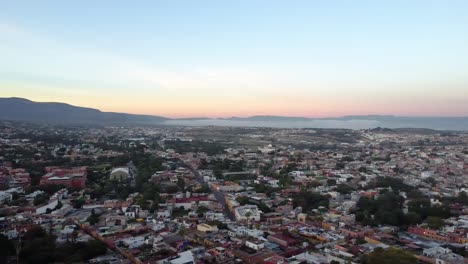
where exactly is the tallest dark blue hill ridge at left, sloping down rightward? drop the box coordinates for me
[0,97,168,125]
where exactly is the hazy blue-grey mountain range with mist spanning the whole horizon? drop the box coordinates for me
[0,97,468,130]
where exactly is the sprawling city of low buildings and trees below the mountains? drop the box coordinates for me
[0,121,468,263]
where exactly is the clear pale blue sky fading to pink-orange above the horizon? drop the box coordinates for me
[0,0,468,117]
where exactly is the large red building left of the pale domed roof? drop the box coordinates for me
[40,167,87,189]
